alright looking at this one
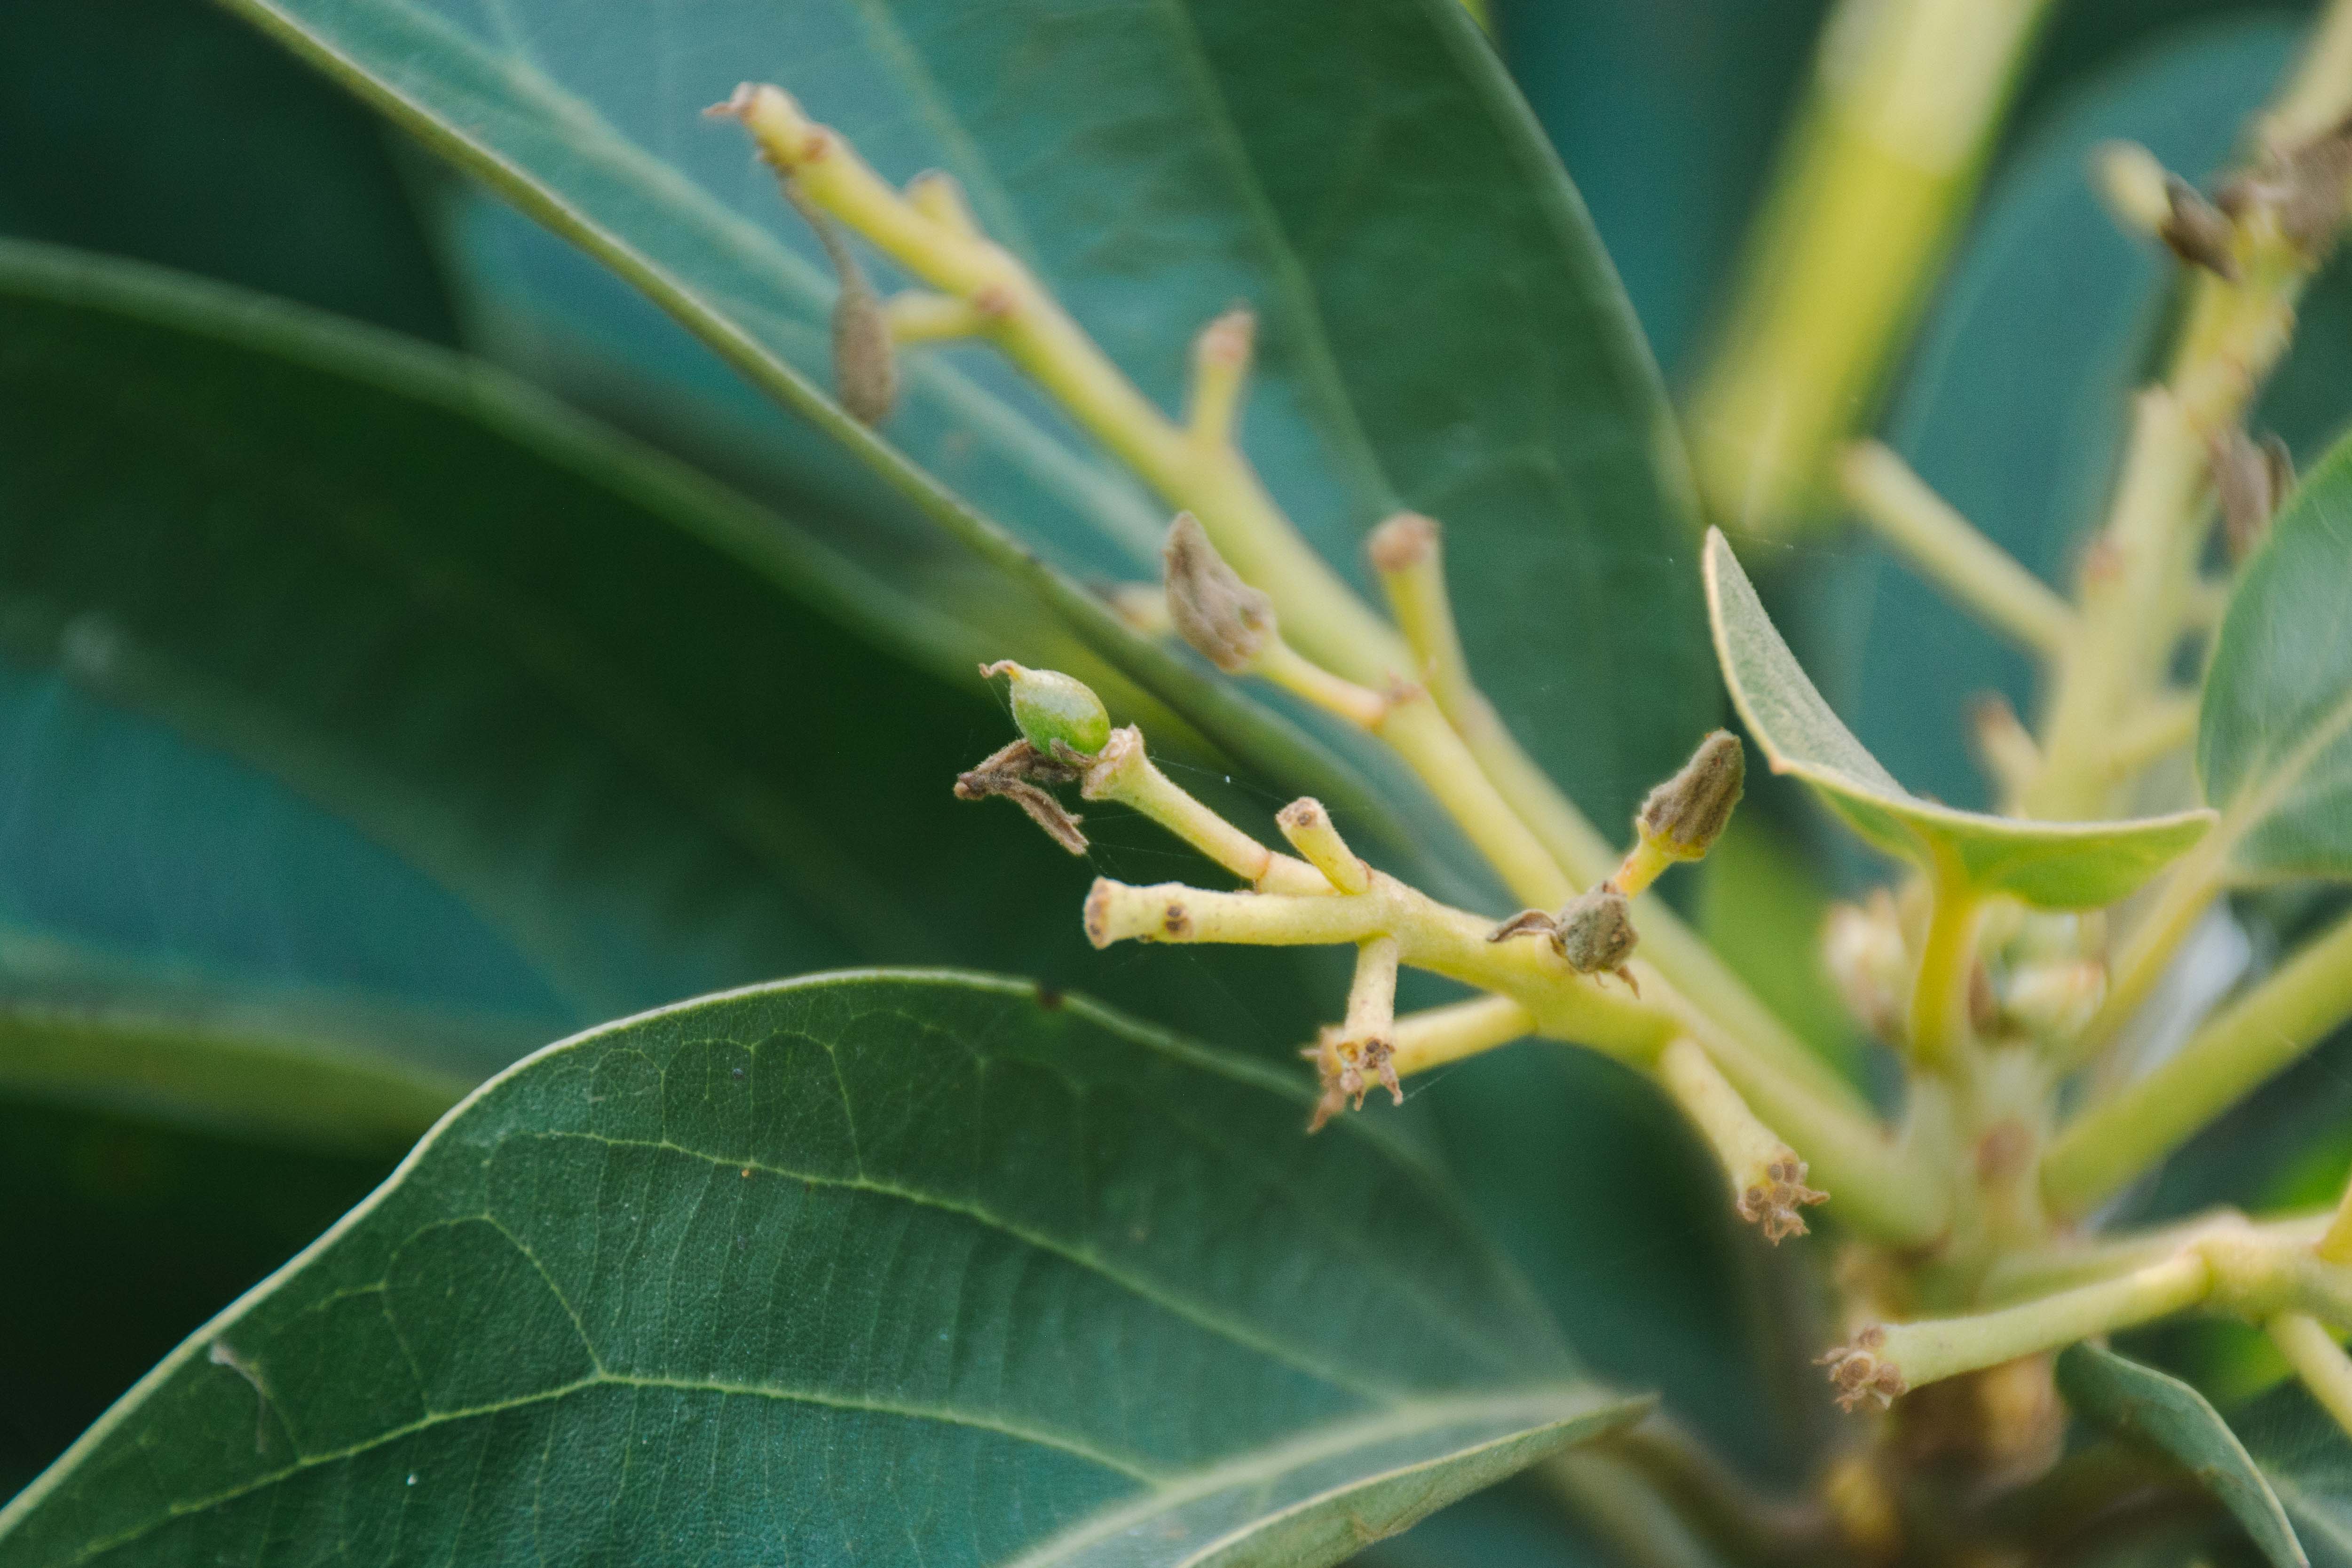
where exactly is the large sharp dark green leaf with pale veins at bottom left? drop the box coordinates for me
[0,973,1649,1568]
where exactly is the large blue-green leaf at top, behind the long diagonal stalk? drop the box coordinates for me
[237,0,1714,846]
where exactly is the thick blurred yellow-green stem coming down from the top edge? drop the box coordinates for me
[1689,0,2049,531]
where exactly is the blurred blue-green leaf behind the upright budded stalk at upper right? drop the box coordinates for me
[1853,21,2295,806]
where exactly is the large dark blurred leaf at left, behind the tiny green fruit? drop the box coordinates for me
[0,249,1355,1081]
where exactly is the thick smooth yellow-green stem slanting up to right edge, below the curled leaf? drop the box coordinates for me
[2042,917,2352,1215]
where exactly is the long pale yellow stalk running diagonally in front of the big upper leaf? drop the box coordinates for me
[710,85,1861,1128]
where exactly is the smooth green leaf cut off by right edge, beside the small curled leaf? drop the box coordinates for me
[2197,430,2352,879]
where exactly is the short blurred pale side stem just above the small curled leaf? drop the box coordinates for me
[1837,442,2075,656]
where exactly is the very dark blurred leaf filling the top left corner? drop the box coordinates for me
[0,0,456,343]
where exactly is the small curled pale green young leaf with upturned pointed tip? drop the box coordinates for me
[1707,529,2213,910]
